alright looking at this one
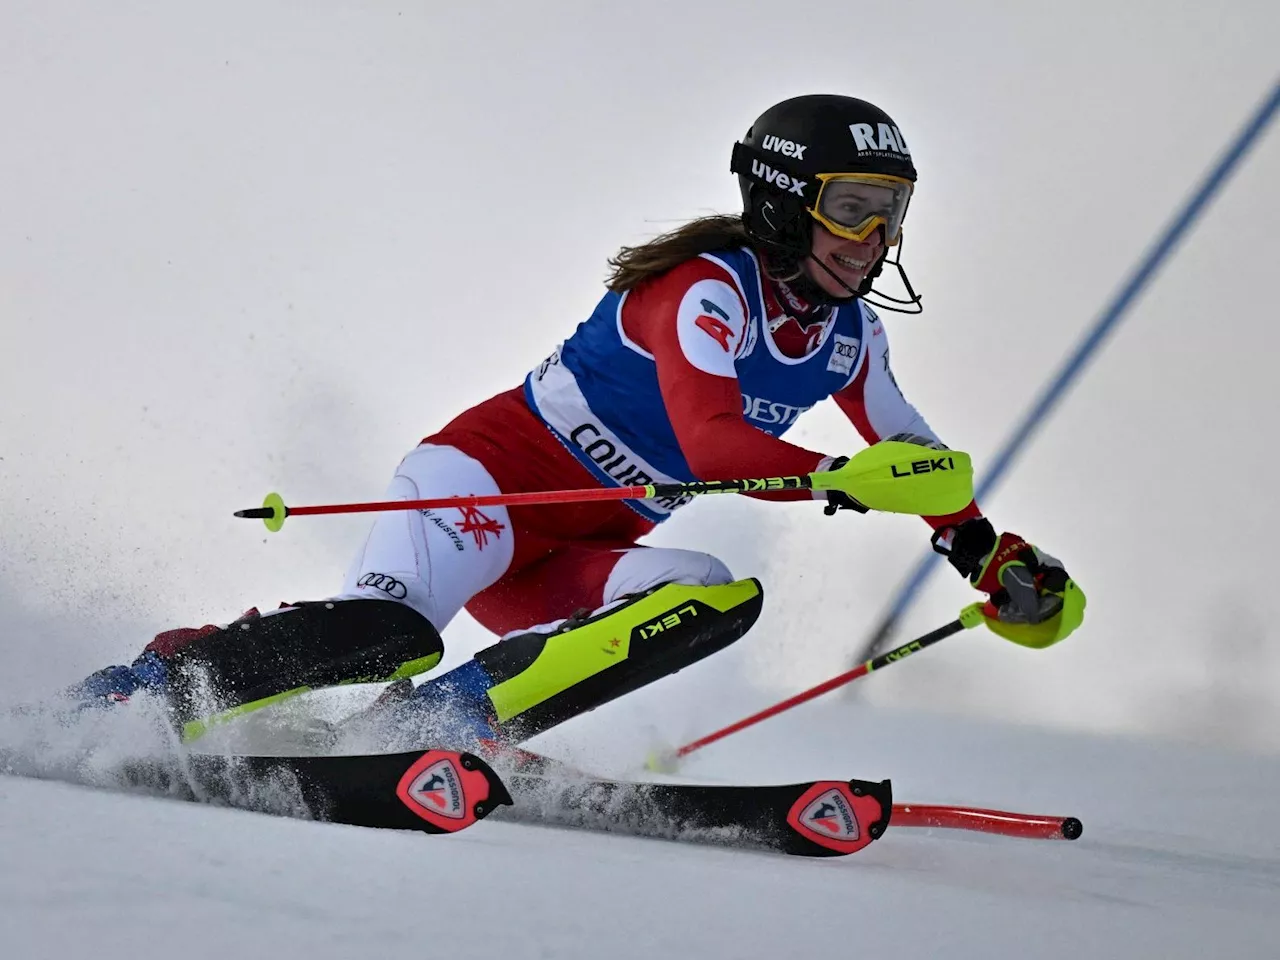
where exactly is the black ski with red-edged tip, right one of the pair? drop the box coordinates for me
[489,748,893,856]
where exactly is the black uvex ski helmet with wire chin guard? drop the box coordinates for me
[730,93,918,301]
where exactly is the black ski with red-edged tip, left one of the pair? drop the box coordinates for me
[116,750,511,833]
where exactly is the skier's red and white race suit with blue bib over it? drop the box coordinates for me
[340,250,978,634]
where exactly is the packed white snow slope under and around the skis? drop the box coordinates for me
[0,700,1280,960]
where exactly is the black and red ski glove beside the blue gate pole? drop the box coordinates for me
[933,517,1068,625]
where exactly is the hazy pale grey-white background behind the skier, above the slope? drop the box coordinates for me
[0,0,1280,748]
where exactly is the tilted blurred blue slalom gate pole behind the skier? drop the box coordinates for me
[854,81,1280,663]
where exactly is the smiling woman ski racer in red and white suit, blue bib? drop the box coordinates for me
[76,95,1066,742]
